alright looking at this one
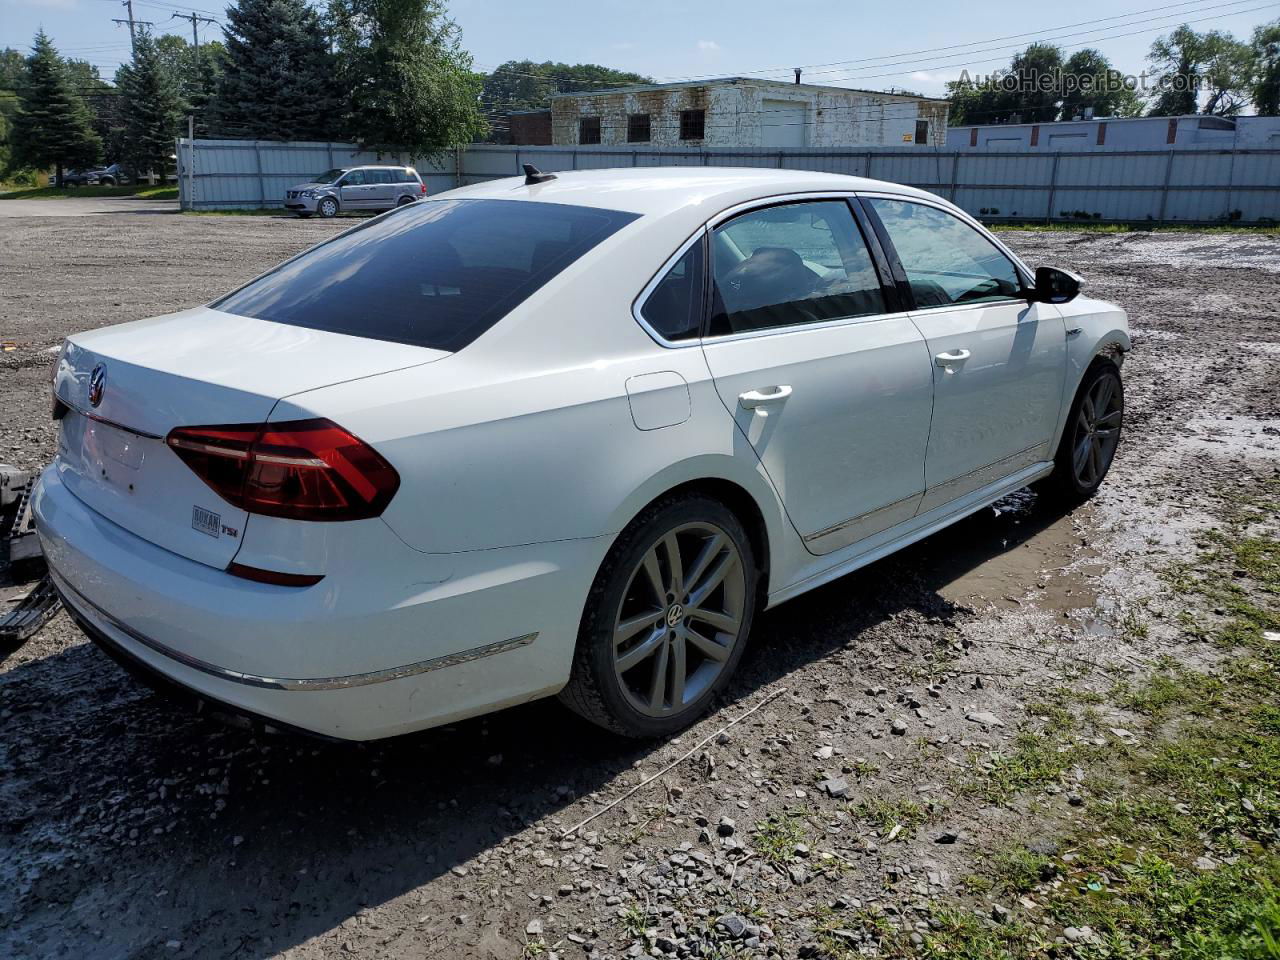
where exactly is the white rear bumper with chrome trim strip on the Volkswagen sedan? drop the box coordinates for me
[33,471,604,740]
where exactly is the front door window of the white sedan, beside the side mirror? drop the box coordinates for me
[869,200,1021,308]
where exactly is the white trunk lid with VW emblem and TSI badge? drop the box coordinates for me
[54,307,448,567]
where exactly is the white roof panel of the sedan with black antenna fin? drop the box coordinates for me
[435,166,938,216]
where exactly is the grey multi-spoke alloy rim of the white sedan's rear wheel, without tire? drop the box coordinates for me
[613,522,748,717]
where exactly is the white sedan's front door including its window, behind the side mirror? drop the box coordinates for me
[863,197,1066,512]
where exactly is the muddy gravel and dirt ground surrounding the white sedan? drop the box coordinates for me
[0,216,1280,960]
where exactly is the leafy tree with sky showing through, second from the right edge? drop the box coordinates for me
[1148,23,1253,116]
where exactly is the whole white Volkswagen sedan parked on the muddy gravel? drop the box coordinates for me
[35,169,1129,740]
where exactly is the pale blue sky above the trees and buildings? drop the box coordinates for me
[0,0,1280,95]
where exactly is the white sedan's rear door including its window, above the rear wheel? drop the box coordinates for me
[703,197,933,554]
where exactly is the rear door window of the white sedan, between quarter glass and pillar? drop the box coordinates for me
[710,200,884,335]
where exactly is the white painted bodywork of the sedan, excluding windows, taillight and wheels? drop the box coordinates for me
[35,169,1129,740]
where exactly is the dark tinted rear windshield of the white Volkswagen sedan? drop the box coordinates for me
[211,200,650,351]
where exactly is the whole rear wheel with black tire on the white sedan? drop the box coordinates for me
[559,494,759,737]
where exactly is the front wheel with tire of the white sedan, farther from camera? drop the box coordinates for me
[1038,357,1124,506]
